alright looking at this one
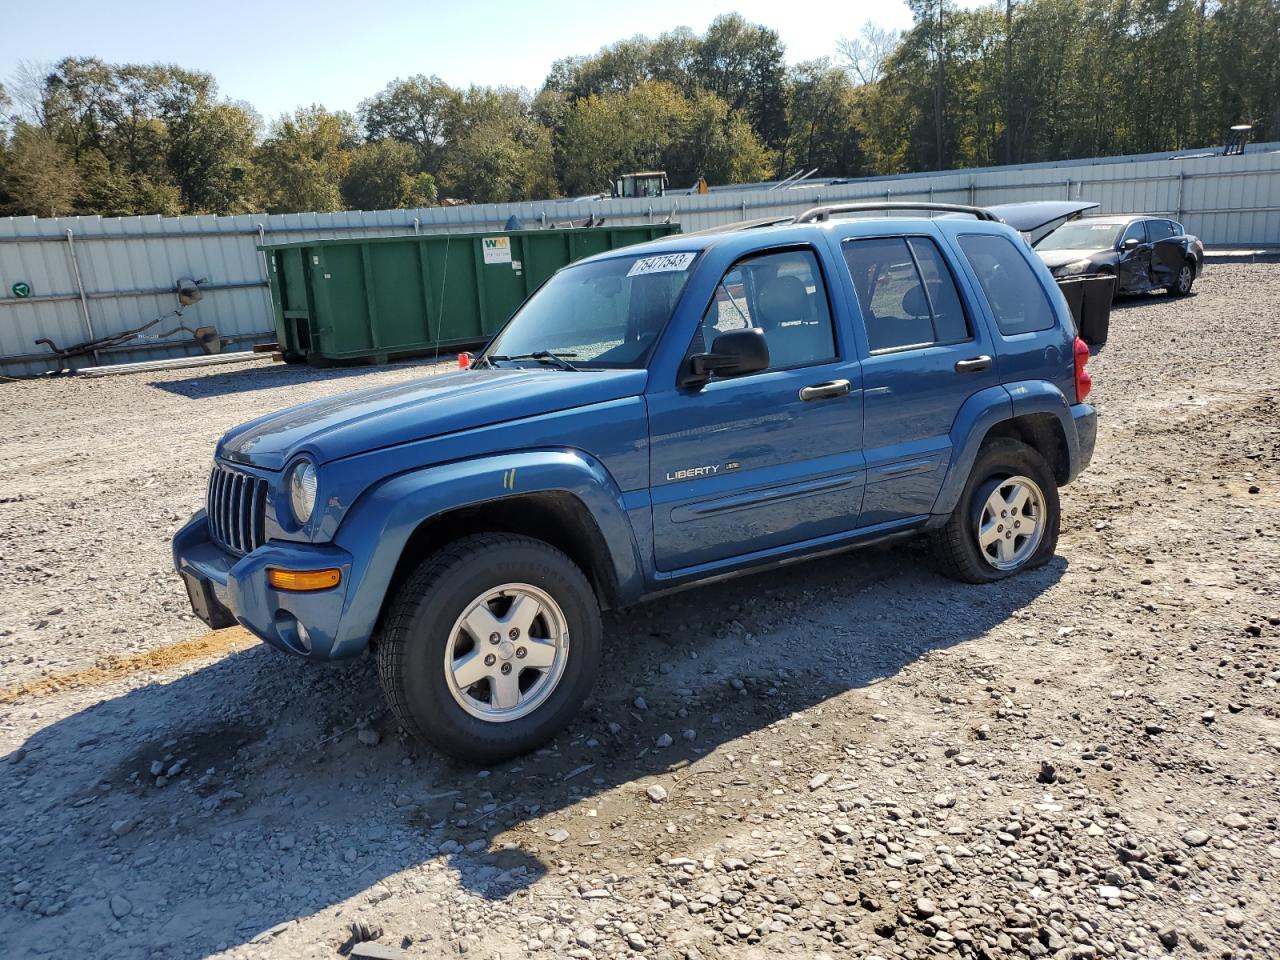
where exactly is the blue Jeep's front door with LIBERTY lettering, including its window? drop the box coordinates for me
[648,247,863,572]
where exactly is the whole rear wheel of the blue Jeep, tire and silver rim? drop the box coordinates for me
[933,438,1061,584]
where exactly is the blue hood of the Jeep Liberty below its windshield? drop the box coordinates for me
[218,369,648,470]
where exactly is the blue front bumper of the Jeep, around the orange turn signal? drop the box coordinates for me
[173,511,369,659]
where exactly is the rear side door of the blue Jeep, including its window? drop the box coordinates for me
[841,224,998,527]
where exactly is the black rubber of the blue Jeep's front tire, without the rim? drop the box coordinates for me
[378,534,602,764]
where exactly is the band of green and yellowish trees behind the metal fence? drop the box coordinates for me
[0,0,1280,215]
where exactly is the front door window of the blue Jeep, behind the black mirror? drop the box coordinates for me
[692,250,836,370]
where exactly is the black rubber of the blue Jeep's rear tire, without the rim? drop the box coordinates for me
[932,438,1061,584]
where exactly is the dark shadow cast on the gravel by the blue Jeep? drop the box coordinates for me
[0,545,1068,957]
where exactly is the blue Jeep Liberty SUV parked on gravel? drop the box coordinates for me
[173,204,1097,763]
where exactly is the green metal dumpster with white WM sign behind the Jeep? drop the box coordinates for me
[260,224,680,366]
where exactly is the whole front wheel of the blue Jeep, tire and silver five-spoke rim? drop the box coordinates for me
[378,534,600,763]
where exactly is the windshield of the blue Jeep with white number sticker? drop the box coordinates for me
[485,253,698,367]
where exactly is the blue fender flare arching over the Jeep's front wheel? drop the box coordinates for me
[320,449,643,653]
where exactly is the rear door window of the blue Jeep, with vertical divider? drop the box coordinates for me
[844,237,973,352]
